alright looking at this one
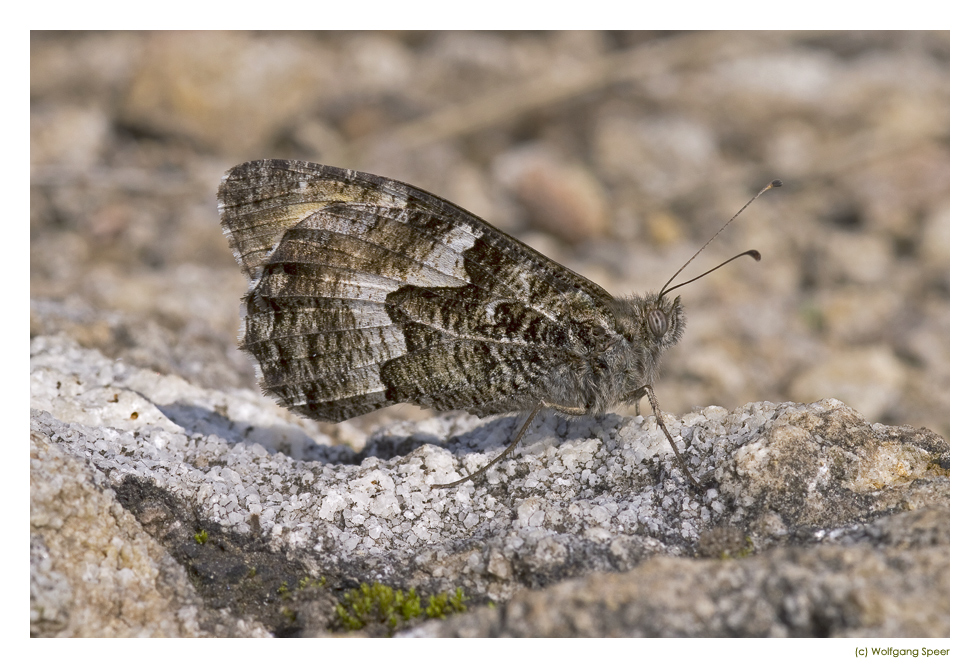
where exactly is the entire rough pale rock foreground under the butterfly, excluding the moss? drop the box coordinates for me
[31,336,949,636]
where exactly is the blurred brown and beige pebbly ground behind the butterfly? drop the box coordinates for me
[30,32,950,438]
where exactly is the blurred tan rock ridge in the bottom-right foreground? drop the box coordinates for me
[412,536,949,638]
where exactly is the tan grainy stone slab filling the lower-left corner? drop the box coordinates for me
[31,431,267,637]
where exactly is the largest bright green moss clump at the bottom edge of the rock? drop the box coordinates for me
[337,582,467,632]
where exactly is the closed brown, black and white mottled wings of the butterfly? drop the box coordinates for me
[218,160,613,421]
